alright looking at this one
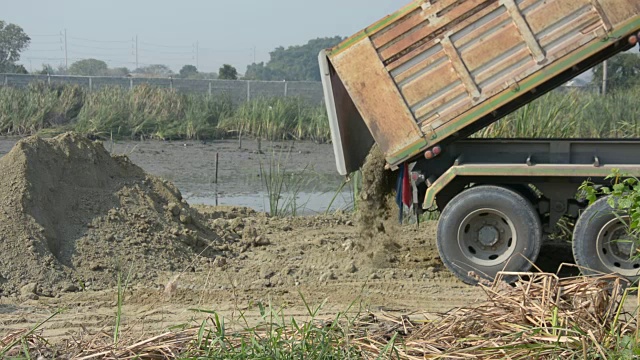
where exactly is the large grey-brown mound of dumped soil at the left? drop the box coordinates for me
[0,133,224,295]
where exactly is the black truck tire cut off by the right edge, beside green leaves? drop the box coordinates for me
[573,197,640,282]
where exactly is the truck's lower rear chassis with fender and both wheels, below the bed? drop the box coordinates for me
[412,139,640,283]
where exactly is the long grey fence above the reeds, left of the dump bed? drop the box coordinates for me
[0,74,324,103]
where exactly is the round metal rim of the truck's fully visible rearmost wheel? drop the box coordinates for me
[458,209,518,266]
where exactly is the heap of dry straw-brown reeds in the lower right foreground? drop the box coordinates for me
[357,273,637,359]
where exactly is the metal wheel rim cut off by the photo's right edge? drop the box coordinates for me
[596,218,640,276]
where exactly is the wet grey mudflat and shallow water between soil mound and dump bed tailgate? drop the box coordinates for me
[0,137,351,215]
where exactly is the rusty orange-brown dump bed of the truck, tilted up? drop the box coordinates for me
[320,0,640,174]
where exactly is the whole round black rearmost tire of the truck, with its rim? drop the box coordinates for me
[437,186,542,285]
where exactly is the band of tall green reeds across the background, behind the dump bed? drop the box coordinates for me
[0,84,640,142]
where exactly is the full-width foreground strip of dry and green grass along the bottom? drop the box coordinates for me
[0,273,638,360]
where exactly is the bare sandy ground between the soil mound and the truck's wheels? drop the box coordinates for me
[0,217,482,340]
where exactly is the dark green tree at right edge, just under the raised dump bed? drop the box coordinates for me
[592,53,640,91]
